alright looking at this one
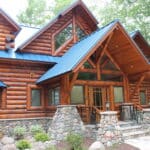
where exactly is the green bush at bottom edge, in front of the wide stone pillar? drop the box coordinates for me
[66,133,83,150]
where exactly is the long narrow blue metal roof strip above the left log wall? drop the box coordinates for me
[0,49,60,63]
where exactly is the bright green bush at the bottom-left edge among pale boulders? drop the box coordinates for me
[16,140,31,150]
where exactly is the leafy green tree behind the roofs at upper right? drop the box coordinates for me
[89,0,150,42]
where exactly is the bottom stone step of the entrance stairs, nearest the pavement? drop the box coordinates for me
[123,130,148,140]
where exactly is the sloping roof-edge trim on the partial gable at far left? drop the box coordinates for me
[0,8,21,32]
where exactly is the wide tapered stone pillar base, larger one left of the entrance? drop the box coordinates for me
[49,105,85,141]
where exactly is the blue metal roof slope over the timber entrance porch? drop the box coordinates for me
[37,20,118,83]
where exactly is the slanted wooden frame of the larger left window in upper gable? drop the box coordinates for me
[52,20,73,55]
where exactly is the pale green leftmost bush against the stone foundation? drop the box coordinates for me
[13,126,26,139]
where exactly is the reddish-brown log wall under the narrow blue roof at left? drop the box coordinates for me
[0,62,54,119]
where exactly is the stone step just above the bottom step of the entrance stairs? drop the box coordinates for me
[119,125,142,133]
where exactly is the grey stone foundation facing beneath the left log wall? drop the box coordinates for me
[0,117,52,136]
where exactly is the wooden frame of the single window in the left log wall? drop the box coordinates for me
[27,85,44,110]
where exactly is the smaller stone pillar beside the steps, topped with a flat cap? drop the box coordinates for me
[97,111,122,146]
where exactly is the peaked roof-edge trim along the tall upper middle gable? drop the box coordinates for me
[17,0,98,50]
